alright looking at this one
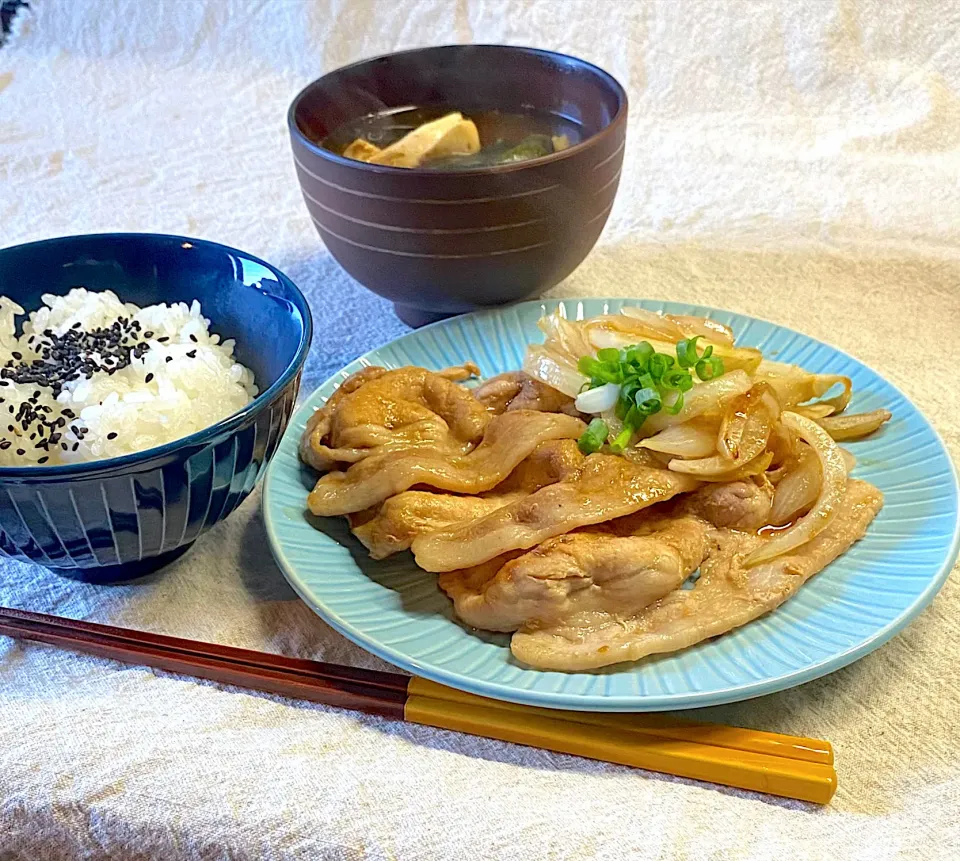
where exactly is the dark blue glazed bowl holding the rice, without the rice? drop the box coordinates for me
[0,233,313,583]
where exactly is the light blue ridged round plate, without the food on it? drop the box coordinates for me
[264,299,960,711]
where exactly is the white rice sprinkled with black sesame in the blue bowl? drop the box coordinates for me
[0,288,257,466]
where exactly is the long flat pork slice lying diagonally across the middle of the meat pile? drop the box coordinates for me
[411,456,699,571]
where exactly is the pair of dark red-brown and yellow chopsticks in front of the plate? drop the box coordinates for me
[0,608,837,804]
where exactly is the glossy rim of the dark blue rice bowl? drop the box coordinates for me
[0,232,313,481]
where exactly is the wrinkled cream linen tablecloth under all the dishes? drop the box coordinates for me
[0,0,960,861]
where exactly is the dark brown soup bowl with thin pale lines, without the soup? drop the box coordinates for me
[289,45,627,326]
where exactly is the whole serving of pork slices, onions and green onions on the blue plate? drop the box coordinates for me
[301,308,890,671]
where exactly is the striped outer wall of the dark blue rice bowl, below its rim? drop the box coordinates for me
[0,378,299,582]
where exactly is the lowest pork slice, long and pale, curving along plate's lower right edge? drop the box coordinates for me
[511,480,883,672]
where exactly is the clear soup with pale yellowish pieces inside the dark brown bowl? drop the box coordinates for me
[321,107,583,170]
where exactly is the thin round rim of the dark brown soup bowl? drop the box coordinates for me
[287,42,630,177]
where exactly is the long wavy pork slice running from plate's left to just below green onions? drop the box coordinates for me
[307,410,584,516]
